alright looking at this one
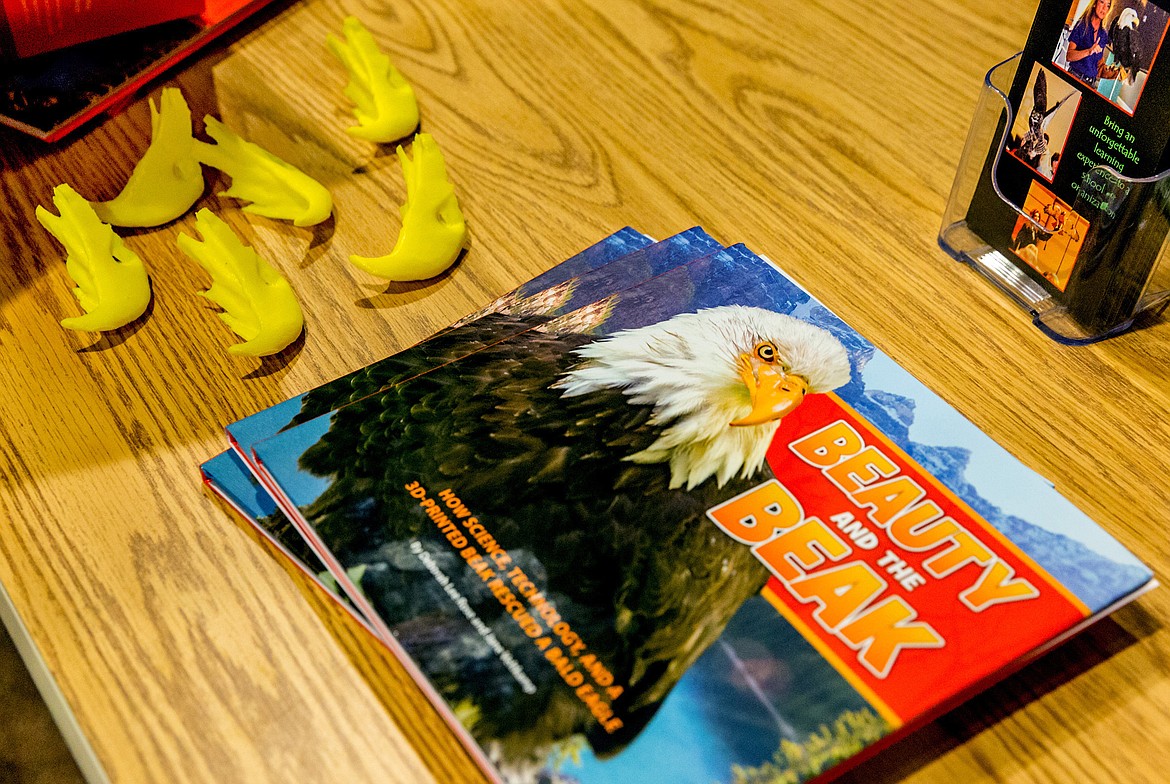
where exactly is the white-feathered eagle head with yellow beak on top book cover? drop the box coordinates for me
[556,305,849,489]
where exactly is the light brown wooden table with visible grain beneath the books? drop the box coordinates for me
[0,0,1170,784]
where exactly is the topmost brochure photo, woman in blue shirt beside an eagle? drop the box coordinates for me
[1052,0,1170,115]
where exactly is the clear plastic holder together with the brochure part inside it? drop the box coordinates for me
[938,48,1170,344]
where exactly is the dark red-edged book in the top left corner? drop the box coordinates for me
[0,0,278,142]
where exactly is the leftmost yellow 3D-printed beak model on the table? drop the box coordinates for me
[36,185,150,331]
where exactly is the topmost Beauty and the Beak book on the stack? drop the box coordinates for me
[242,236,1152,784]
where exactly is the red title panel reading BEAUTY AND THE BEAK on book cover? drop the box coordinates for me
[709,394,1088,723]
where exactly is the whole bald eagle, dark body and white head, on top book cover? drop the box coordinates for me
[256,278,851,780]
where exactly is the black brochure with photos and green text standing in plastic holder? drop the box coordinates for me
[966,0,1170,335]
